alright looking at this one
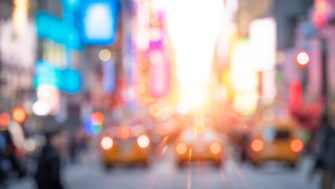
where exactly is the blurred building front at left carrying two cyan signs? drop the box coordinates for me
[32,0,83,127]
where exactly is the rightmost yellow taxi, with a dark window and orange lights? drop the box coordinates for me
[249,120,304,168]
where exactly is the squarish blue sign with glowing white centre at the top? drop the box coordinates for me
[81,0,119,45]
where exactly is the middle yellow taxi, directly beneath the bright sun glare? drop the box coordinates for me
[175,128,224,167]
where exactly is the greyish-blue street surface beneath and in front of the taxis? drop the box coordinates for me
[9,145,318,189]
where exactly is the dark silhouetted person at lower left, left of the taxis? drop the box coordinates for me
[35,128,66,189]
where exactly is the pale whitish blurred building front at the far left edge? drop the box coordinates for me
[0,0,37,118]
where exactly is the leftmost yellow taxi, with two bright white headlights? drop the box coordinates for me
[100,125,152,168]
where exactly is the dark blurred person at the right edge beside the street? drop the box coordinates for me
[312,116,335,189]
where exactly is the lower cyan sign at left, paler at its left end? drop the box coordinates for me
[34,60,82,94]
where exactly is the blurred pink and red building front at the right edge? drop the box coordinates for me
[281,0,335,131]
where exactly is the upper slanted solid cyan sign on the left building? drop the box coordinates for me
[36,11,81,49]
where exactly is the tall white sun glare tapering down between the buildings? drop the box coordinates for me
[166,0,223,110]
